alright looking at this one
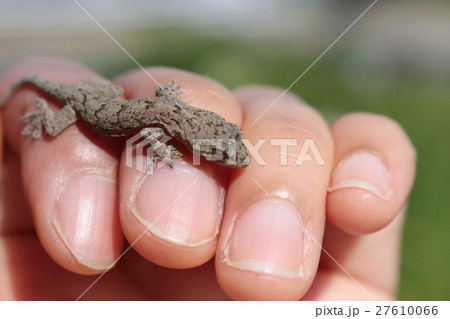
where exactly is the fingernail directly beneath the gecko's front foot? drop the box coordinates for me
[132,163,224,247]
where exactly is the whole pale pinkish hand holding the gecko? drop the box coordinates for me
[0,59,416,300]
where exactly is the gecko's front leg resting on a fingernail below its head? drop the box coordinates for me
[140,127,183,168]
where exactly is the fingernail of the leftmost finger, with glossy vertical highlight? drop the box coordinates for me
[53,175,120,269]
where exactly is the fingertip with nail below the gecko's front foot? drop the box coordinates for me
[120,160,223,269]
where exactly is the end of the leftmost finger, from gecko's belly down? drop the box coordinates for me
[21,134,123,274]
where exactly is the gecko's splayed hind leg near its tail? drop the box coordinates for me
[22,99,77,139]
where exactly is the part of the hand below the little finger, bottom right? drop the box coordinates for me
[303,209,405,300]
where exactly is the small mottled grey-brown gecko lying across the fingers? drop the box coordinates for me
[0,75,251,168]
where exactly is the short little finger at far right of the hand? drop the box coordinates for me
[327,113,416,234]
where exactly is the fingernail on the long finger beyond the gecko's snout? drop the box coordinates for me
[224,201,303,278]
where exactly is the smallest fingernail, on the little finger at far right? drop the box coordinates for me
[328,152,390,200]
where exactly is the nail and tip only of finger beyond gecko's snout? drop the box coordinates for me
[216,200,312,300]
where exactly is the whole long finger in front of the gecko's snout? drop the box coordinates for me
[216,87,333,300]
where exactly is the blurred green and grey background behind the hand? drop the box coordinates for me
[0,0,450,300]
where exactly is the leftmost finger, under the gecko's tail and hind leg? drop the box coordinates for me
[0,59,123,273]
